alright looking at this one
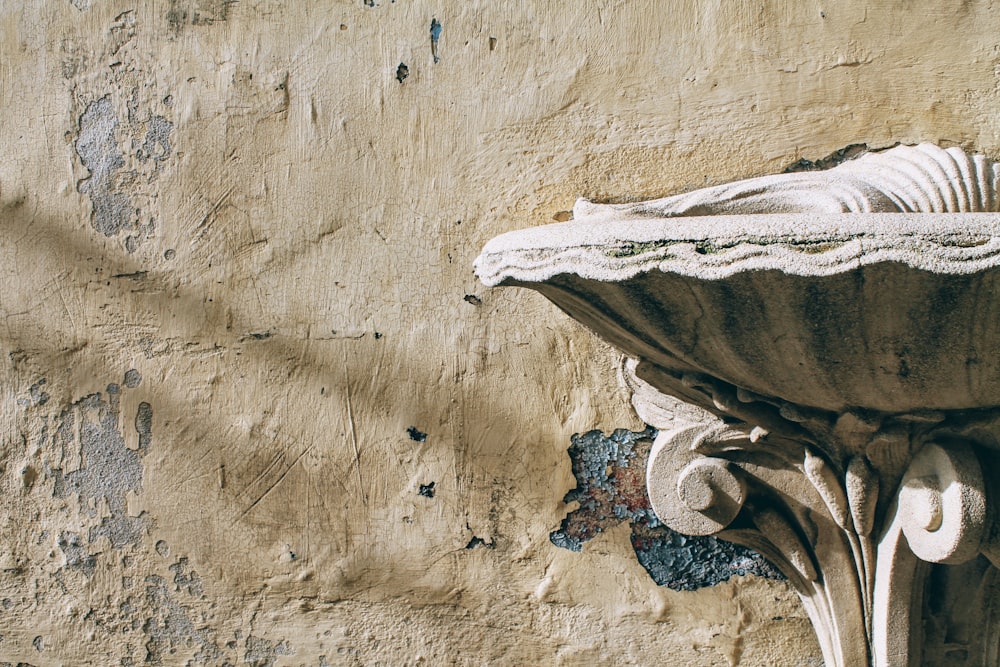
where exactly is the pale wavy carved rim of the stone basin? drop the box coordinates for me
[475,207,1000,286]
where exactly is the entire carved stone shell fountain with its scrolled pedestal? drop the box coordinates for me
[476,144,1000,667]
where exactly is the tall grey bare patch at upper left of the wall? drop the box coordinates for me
[76,95,138,236]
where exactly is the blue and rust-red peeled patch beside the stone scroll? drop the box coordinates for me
[549,427,784,590]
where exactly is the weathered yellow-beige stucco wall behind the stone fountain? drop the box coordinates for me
[0,0,1000,665]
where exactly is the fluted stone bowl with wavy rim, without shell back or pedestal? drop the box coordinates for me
[476,213,1000,413]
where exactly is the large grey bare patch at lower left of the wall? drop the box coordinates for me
[51,384,153,558]
